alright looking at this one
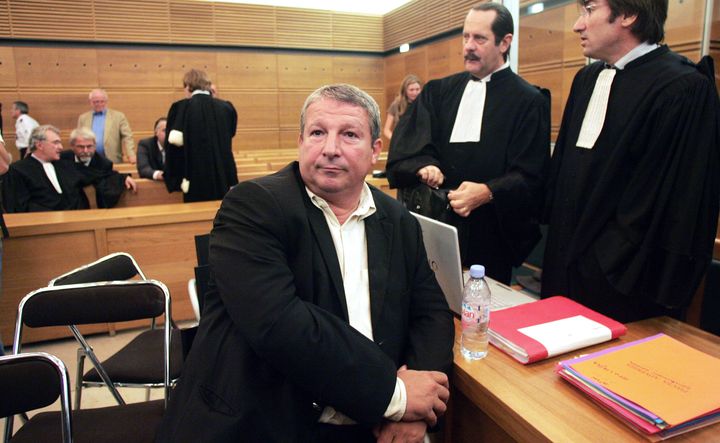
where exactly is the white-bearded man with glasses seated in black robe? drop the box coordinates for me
[60,128,137,208]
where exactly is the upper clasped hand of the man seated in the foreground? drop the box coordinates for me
[397,366,450,426]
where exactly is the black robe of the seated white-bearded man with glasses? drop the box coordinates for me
[60,151,129,208]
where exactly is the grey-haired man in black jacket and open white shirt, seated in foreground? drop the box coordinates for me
[158,85,454,442]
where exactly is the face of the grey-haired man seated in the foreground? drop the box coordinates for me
[298,98,382,202]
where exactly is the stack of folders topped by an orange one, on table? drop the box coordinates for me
[556,334,720,439]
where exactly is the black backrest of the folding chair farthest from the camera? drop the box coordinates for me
[48,252,146,286]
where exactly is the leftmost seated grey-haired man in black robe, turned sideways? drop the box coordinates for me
[2,125,129,213]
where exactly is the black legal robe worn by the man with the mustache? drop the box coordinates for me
[387,68,550,280]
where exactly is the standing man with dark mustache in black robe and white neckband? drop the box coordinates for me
[387,3,550,283]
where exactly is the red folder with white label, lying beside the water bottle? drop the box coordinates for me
[489,296,627,364]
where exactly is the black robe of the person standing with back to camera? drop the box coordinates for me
[164,94,238,202]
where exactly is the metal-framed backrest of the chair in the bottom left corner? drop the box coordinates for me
[0,352,72,442]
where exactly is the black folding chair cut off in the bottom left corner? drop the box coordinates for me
[0,352,164,443]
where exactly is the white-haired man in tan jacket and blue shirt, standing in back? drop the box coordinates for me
[78,89,136,163]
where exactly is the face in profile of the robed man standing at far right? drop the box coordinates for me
[573,0,626,64]
